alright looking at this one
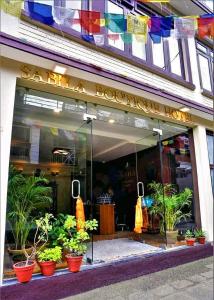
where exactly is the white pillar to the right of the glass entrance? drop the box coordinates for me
[193,126,213,241]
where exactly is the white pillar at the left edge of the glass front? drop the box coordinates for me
[0,63,16,285]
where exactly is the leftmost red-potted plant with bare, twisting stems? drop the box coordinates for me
[13,214,53,283]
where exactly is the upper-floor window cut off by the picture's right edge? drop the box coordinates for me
[196,42,213,93]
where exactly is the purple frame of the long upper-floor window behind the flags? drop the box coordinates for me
[24,0,195,90]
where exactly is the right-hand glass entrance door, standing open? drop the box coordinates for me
[135,128,166,248]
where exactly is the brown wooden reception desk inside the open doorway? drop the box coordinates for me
[99,204,115,234]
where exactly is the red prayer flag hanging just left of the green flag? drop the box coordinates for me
[80,10,100,33]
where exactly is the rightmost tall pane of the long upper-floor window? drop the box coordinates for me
[168,37,181,76]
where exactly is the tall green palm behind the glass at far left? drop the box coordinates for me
[7,166,52,249]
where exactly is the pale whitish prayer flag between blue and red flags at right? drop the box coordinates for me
[174,18,195,39]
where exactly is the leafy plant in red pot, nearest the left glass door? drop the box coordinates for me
[58,215,98,272]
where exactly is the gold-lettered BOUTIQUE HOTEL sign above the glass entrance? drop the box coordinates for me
[21,66,192,123]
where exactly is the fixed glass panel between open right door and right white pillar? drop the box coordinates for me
[161,122,195,246]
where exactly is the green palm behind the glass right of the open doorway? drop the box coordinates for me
[148,181,192,232]
